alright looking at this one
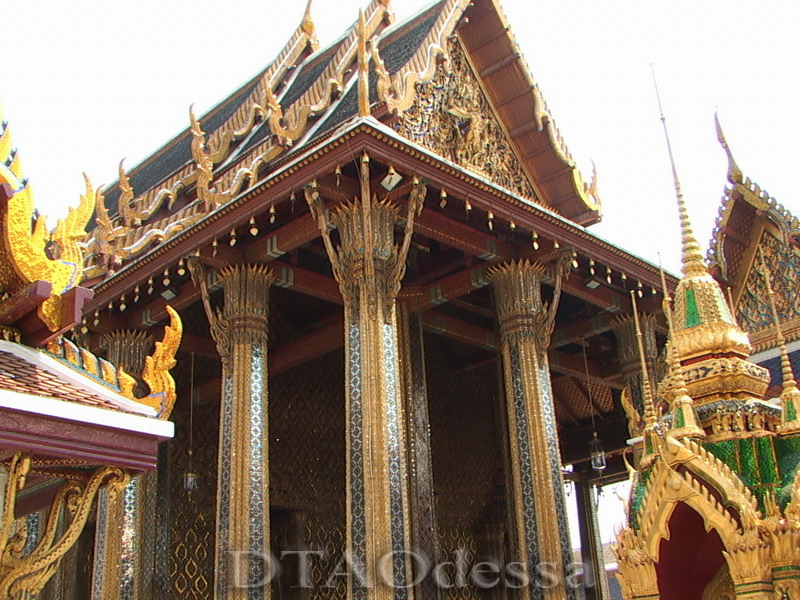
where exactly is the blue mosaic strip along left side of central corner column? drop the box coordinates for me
[347,308,367,600]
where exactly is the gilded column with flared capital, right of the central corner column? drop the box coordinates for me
[489,252,575,600]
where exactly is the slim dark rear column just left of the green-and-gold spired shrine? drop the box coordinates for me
[575,472,611,600]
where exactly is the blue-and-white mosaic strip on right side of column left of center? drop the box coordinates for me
[247,343,269,600]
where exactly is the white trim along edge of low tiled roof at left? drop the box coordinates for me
[0,390,175,438]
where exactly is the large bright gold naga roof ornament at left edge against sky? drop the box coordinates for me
[0,107,95,331]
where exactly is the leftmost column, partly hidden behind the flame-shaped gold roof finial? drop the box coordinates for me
[92,330,158,600]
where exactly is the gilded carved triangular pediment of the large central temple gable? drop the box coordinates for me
[394,37,536,200]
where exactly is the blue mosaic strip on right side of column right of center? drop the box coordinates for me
[537,352,575,600]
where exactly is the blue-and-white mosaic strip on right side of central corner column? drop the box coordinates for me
[381,323,408,600]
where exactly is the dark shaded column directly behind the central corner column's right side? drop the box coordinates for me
[398,302,439,600]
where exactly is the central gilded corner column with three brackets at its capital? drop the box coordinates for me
[306,154,426,600]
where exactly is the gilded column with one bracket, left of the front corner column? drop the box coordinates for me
[190,261,274,600]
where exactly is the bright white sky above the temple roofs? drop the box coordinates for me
[0,0,800,270]
